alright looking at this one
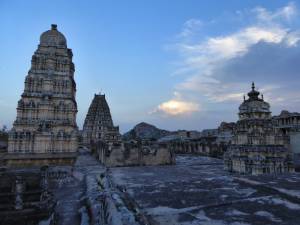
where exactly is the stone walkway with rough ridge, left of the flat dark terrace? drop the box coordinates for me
[48,149,143,225]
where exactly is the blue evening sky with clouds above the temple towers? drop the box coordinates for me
[0,0,300,132]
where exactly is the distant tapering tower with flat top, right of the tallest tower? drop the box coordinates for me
[82,94,121,147]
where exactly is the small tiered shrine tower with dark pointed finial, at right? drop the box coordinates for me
[224,83,294,175]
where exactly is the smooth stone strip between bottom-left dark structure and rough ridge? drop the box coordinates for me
[50,149,105,225]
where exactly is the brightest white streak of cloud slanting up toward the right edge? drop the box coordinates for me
[179,26,288,67]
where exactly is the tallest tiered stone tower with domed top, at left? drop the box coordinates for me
[5,24,78,166]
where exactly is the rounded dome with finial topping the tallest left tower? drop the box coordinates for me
[40,24,67,47]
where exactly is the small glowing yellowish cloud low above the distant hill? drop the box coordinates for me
[154,99,200,116]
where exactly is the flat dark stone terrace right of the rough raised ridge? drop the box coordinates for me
[109,155,300,225]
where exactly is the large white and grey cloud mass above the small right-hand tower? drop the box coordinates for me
[164,3,300,110]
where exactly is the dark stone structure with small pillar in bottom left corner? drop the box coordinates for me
[0,169,55,225]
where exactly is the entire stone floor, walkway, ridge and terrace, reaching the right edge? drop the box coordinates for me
[35,152,300,225]
